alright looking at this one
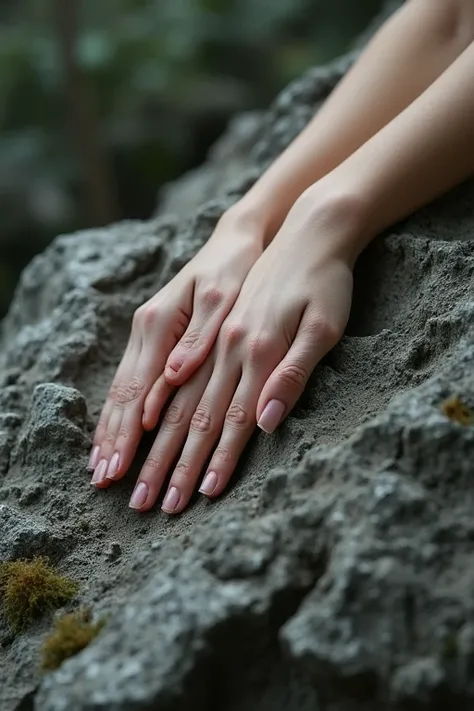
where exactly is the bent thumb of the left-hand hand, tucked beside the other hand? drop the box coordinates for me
[165,286,235,385]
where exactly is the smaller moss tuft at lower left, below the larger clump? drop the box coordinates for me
[41,609,105,671]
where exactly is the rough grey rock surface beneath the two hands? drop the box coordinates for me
[0,2,474,711]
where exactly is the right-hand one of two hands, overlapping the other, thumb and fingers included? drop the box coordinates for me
[126,189,360,513]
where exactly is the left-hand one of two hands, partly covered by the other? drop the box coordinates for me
[89,203,264,485]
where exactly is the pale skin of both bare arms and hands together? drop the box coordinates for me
[89,0,474,513]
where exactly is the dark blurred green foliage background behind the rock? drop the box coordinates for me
[0,0,382,318]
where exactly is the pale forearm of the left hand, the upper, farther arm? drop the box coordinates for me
[235,0,474,242]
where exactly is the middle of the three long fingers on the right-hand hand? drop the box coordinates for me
[162,359,241,514]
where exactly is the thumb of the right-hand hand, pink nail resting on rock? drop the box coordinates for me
[257,310,340,434]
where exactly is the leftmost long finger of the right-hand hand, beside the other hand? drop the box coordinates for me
[129,359,213,511]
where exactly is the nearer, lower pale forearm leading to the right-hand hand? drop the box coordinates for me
[318,42,474,262]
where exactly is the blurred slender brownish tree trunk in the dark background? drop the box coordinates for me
[55,0,119,225]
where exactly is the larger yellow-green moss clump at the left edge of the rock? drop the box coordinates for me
[0,558,78,631]
